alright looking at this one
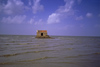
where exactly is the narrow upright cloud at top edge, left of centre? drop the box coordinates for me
[32,0,44,14]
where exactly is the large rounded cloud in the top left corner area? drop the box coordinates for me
[3,0,24,14]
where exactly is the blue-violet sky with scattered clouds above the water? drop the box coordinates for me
[0,0,100,36]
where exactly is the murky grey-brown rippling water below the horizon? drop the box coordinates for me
[0,35,100,67]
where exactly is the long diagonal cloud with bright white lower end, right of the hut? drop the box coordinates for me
[47,0,74,24]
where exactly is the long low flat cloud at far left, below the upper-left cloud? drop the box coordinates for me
[1,15,26,24]
